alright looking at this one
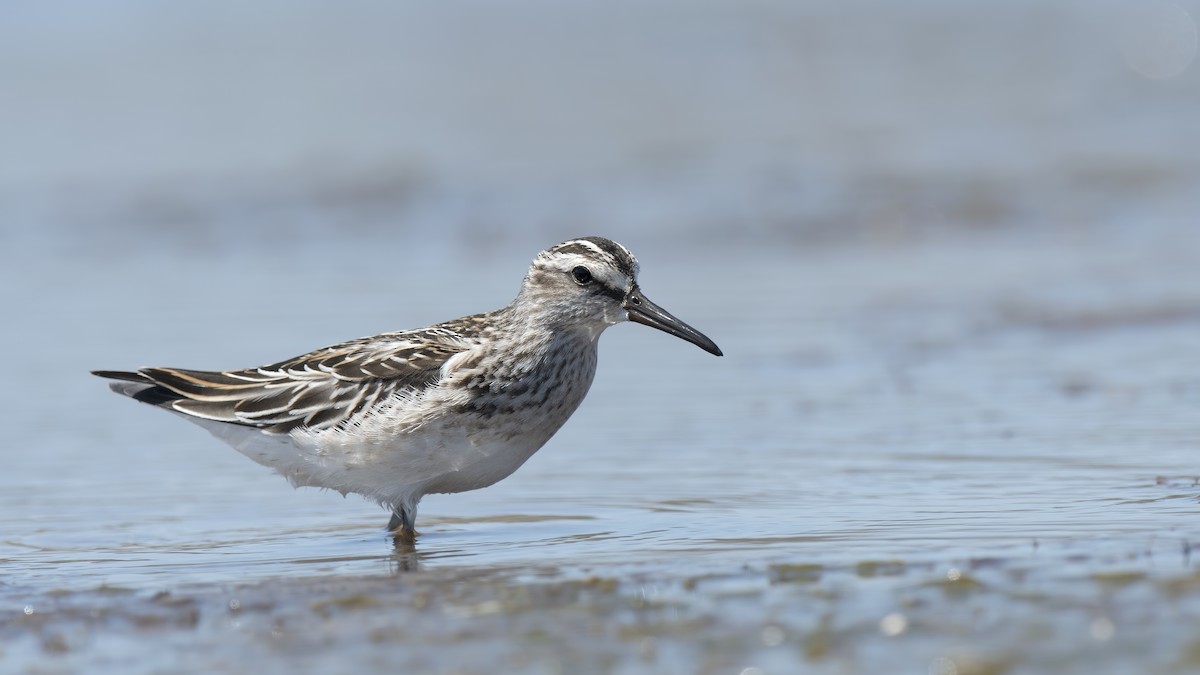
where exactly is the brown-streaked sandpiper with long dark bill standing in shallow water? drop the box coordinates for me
[94,237,721,540]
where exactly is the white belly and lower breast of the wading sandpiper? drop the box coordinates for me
[188,333,595,506]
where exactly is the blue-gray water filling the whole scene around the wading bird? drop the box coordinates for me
[0,1,1200,674]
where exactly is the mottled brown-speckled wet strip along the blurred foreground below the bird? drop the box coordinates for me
[7,546,1200,674]
